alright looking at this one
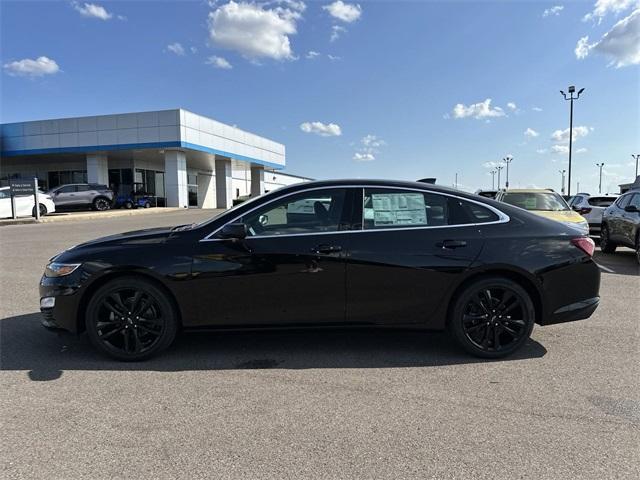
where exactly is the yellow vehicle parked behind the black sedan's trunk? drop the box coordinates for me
[496,189,589,233]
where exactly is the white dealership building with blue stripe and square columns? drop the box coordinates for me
[0,109,310,208]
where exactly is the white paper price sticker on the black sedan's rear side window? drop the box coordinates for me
[371,193,427,227]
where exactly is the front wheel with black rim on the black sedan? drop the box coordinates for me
[85,277,178,362]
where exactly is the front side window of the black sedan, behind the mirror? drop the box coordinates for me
[241,189,345,237]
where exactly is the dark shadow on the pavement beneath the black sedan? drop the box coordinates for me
[0,313,547,381]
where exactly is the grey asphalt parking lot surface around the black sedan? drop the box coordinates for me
[0,210,640,479]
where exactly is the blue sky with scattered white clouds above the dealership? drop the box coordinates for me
[0,0,640,193]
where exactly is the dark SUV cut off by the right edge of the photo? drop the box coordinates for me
[600,190,640,263]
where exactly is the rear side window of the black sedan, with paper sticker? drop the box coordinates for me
[363,188,499,230]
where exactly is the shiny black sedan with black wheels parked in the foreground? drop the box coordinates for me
[40,180,600,360]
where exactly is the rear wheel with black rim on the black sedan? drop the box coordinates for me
[448,277,536,358]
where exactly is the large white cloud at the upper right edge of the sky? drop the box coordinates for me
[575,8,640,68]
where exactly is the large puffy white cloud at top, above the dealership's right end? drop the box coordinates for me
[209,1,305,61]
